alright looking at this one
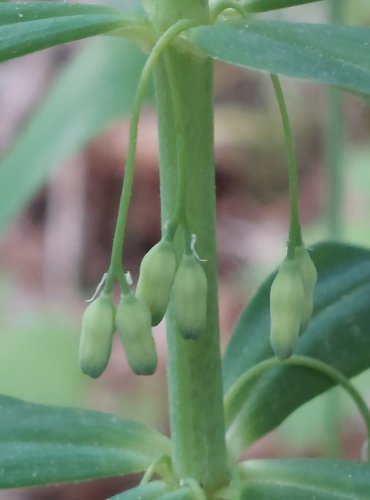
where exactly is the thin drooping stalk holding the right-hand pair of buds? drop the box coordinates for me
[270,75,303,257]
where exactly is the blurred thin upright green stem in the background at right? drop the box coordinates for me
[326,0,343,239]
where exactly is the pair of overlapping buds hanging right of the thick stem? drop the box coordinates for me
[270,246,317,360]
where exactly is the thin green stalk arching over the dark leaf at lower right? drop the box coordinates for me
[224,355,370,458]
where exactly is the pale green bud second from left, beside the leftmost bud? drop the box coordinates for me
[116,294,158,375]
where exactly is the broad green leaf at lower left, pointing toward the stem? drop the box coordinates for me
[0,397,170,488]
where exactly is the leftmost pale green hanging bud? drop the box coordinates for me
[79,293,114,378]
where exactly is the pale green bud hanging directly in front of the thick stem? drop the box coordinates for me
[172,255,208,339]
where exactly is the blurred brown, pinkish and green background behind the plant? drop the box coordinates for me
[0,0,370,500]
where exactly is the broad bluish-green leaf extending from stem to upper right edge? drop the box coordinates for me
[187,18,370,94]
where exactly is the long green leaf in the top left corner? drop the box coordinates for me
[0,2,143,62]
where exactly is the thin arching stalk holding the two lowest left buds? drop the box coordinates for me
[104,20,194,293]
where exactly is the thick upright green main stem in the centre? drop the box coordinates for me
[150,0,228,492]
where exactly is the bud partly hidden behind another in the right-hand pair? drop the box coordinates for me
[295,247,317,331]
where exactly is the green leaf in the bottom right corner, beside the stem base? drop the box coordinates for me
[238,458,370,500]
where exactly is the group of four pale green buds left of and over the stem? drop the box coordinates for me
[79,236,207,378]
